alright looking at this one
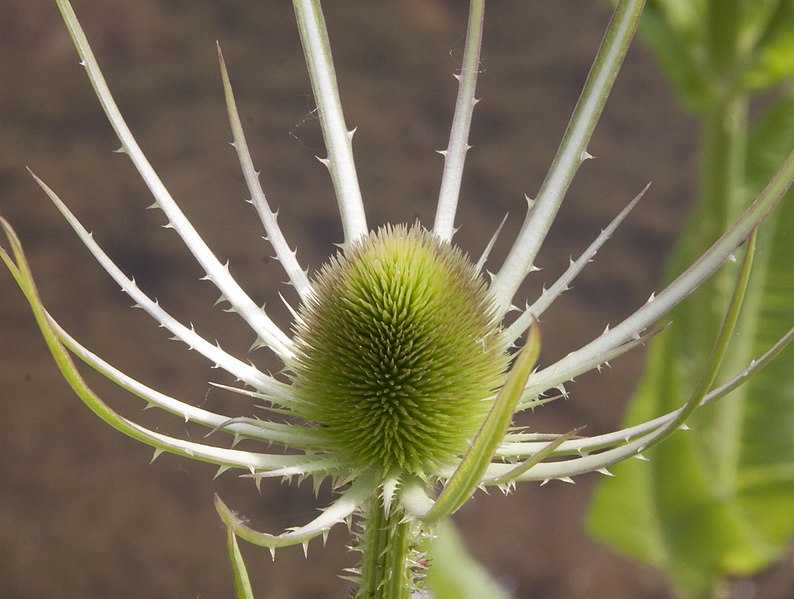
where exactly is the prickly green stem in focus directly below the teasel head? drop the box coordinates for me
[356,499,416,599]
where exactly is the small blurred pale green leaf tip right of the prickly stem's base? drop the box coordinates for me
[427,521,510,599]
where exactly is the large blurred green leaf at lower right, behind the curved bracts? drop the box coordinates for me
[589,88,794,597]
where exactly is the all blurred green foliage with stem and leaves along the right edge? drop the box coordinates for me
[589,0,794,597]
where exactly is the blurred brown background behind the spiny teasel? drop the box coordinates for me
[0,0,772,599]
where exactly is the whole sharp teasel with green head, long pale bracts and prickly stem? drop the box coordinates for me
[0,0,794,599]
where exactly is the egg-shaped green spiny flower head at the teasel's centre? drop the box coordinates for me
[290,225,508,474]
